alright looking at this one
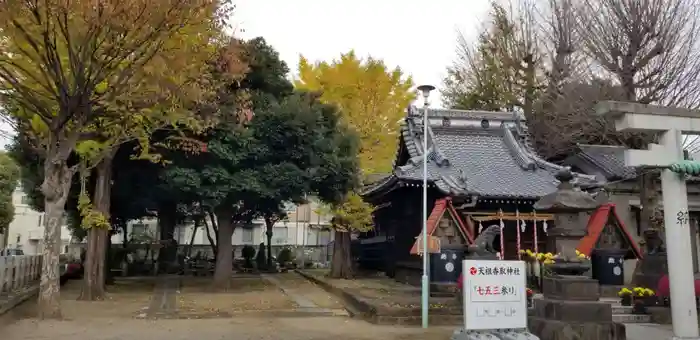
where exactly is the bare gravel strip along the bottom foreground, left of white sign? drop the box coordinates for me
[2,317,452,340]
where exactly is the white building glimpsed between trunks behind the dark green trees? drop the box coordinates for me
[112,202,333,250]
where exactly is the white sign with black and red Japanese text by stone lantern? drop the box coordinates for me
[462,260,527,330]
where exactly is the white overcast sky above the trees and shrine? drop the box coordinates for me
[0,0,489,147]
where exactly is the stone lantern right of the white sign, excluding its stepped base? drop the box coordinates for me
[533,169,600,275]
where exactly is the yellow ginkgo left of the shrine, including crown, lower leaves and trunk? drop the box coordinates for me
[294,51,415,278]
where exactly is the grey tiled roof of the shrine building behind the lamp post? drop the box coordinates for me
[358,108,594,198]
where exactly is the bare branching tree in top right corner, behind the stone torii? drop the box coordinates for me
[577,0,700,229]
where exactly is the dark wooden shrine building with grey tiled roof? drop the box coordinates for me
[354,107,644,284]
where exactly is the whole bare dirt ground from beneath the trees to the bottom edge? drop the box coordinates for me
[0,273,453,340]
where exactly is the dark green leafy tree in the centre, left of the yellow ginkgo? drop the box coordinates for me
[165,93,357,289]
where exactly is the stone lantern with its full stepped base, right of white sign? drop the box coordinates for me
[528,169,626,340]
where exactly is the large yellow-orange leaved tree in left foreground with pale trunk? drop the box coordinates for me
[0,0,246,318]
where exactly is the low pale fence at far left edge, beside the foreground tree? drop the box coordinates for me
[0,255,41,295]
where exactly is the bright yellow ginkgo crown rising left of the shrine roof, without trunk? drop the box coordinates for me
[294,51,415,174]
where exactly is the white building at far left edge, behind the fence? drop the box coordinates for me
[0,185,71,255]
